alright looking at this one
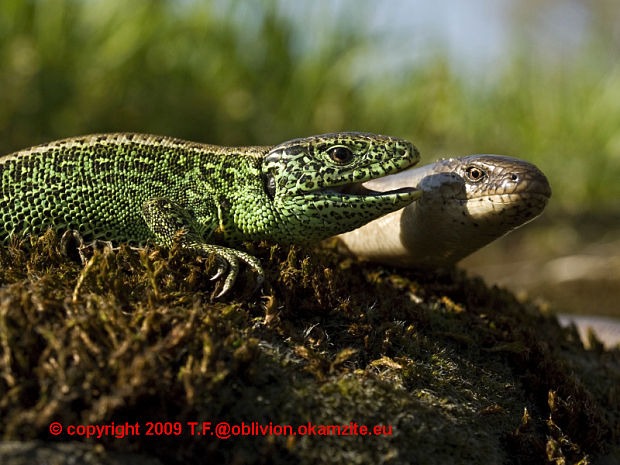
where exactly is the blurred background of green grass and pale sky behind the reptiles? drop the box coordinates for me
[0,0,620,315]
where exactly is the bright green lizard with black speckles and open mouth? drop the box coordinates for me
[0,133,420,297]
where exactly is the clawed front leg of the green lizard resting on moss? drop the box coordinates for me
[142,197,264,297]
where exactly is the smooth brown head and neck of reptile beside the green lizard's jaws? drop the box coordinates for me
[339,155,551,267]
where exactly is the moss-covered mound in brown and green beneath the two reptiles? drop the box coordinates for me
[0,233,620,463]
